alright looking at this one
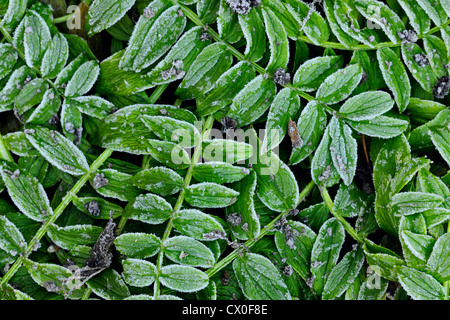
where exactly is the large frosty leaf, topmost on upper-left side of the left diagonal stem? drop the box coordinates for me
[25,126,89,175]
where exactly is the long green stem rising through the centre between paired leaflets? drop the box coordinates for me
[153,116,214,299]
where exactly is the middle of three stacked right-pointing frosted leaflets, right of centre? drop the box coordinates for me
[339,91,394,121]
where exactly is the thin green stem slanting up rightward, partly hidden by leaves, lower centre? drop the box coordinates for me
[205,181,315,278]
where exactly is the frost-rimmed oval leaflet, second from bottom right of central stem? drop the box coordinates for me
[163,236,215,268]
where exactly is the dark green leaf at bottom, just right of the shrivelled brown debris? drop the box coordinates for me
[87,269,130,300]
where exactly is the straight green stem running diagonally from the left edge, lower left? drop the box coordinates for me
[0,149,113,288]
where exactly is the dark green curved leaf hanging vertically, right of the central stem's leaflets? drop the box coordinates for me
[226,172,261,240]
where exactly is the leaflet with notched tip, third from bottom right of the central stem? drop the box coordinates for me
[173,209,226,241]
